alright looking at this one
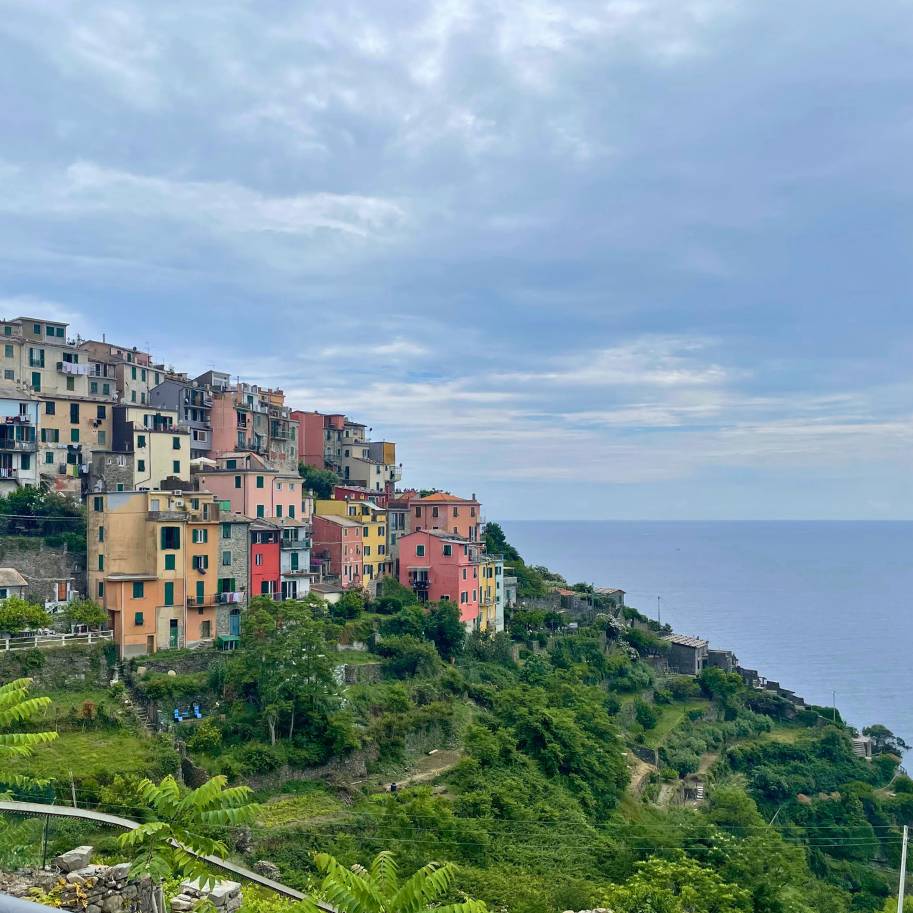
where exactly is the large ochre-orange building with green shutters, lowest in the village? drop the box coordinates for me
[87,490,226,657]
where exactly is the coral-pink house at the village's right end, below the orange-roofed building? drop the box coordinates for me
[398,530,480,625]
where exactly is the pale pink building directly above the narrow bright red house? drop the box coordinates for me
[198,452,302,520]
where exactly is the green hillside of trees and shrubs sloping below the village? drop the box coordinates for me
[0,524,913,913]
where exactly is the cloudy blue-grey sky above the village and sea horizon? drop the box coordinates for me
[0,0,913,519]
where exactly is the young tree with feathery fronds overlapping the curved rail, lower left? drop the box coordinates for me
[117,776,256,909]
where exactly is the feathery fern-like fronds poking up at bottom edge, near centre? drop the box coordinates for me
[312,851,487,913]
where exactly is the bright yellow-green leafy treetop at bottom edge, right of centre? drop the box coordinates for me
[606,853,752,913]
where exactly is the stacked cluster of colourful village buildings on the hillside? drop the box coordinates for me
[0,317,506,656]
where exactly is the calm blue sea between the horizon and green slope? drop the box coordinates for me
[502,521,913,743]
